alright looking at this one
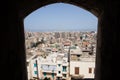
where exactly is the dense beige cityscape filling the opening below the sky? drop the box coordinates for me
[25,31,97,80]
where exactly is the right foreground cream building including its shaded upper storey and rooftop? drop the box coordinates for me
[70,45,95,79]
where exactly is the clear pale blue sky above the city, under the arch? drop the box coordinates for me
[24,3,98,31]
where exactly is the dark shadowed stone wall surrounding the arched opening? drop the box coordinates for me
[6,0,120,80]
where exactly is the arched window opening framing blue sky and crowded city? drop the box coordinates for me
[24,3,98,80]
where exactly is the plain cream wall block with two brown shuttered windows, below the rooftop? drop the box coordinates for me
[70,61,95,79]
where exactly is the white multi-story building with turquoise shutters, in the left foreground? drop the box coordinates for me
[27,53,69,80]
